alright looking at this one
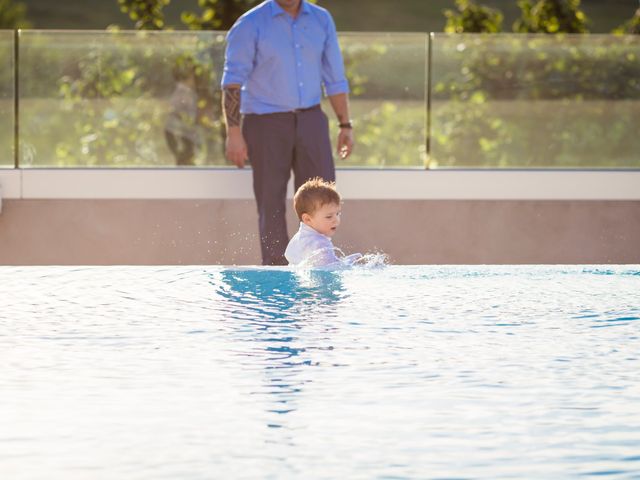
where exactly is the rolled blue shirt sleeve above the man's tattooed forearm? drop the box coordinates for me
[220,18,257,88]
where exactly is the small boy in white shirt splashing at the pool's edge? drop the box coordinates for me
[284,177,361,267]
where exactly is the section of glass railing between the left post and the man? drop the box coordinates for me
[19,31,226,167]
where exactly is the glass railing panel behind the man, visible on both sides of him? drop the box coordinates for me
[19,31,427,167]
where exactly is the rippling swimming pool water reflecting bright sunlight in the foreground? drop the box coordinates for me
[0,266,640,480]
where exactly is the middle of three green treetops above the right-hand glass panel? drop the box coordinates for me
[513,0,589,33]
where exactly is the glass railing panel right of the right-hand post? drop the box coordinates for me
[429,34,640,168]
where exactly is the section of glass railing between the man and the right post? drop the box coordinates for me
[323,33,428,168]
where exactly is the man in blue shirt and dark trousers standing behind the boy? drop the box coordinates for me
[222,0,353,265]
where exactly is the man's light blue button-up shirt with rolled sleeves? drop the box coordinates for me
[221,0,349,114]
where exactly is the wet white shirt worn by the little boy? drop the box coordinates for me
[284,222,341,267]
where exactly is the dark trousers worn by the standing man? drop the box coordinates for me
[242,106,336,265]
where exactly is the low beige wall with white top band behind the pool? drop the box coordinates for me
[0,169,640,265]
